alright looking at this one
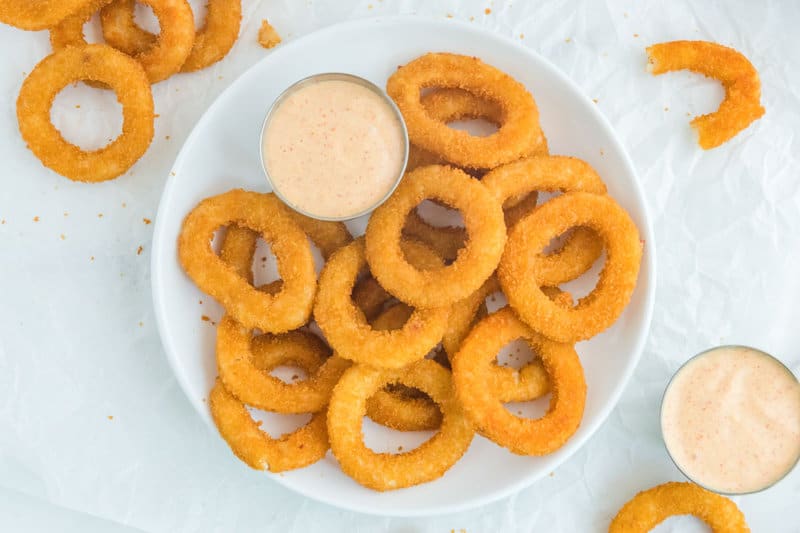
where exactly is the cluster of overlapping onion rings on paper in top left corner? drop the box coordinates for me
[0,0,247,183]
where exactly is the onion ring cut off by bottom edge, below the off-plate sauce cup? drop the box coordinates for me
[608,481,750,533]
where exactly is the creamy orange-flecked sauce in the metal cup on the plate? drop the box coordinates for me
[261,80,406,218]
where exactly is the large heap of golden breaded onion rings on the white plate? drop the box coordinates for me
[175,52,642,491]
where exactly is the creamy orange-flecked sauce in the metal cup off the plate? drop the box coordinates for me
[661,346,800,494]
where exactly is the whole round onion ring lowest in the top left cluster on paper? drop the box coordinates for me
[17,45,154,182]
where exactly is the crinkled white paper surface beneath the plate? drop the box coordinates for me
[0,0,800,533]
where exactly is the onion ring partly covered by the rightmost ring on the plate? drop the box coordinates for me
[483,156,606,286]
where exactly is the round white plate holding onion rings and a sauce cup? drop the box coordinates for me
[152,17,655,516]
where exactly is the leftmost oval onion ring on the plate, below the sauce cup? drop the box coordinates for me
[178,189,316,333]
